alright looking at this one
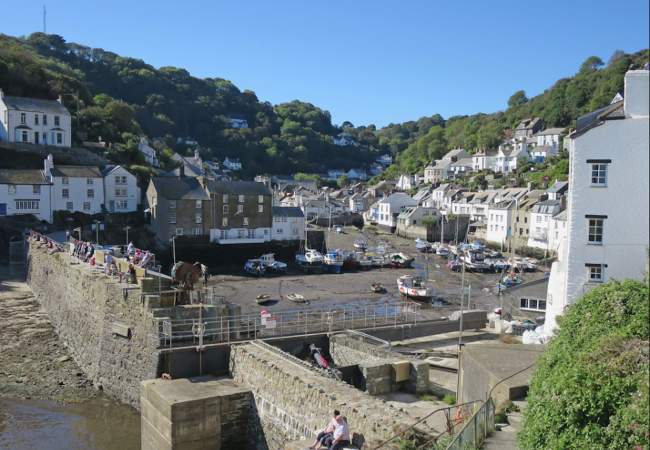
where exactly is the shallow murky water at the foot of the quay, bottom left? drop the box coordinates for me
[0,399,140,450]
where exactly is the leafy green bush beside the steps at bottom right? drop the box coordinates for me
[519,279,650,450]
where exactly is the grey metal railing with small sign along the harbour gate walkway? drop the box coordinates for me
[157,302,420,348]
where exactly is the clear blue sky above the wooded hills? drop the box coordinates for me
[0,0,650,128]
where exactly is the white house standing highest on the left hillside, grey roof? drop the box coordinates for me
[0,88,72,147]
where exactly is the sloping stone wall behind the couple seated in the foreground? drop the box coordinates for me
[230,344,432,450]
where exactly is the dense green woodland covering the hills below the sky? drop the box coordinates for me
[0,33,648,182]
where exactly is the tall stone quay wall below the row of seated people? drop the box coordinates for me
[27,244,161,409]
